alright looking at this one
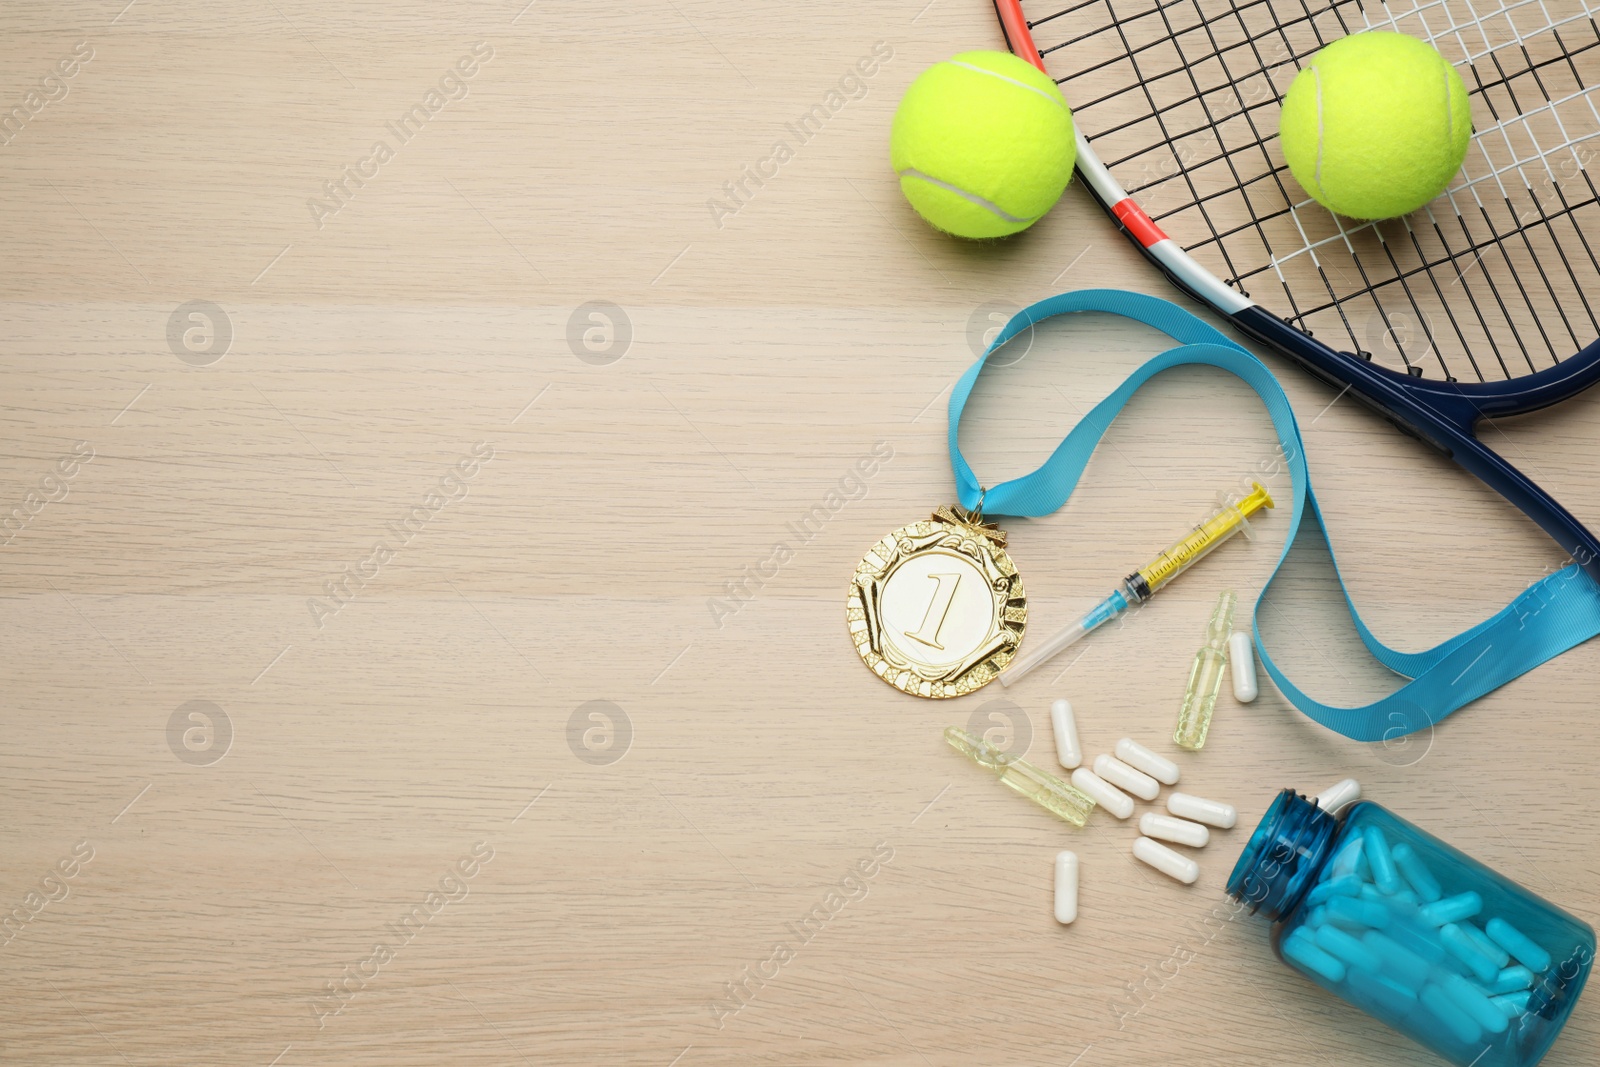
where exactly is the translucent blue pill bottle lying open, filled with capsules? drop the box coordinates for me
[1227,789,1595,1067]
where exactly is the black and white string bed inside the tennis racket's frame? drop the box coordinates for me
[1029,0,1600,381]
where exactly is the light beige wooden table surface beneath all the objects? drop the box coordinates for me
[0,0,1600,1067]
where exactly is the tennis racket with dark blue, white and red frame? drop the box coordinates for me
[994,0,1600,579]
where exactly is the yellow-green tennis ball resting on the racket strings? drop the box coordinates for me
[1278,30,1472,219]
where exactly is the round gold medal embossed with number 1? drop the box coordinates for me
[845,504,1027,699]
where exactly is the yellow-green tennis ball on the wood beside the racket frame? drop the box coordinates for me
[890,51,1078,238]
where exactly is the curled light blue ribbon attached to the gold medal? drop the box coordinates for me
[949,290,1600,741]
